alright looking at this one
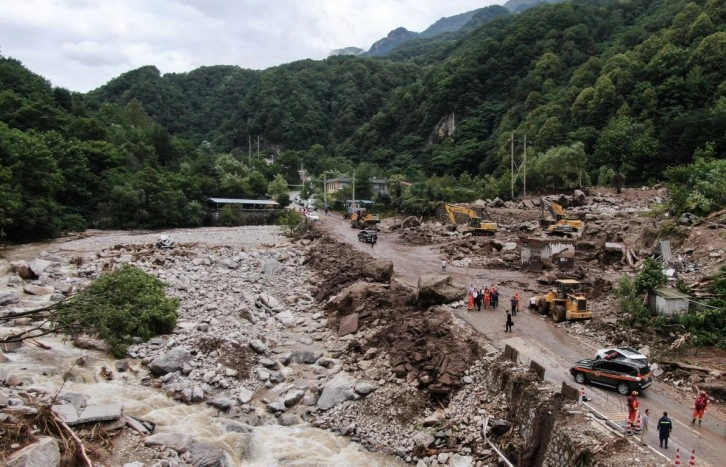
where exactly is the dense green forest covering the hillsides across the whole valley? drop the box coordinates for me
[0,0,726,240]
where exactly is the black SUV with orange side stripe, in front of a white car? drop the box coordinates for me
[570,357,653,395]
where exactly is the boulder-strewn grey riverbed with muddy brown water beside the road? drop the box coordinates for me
[0,227,668,467]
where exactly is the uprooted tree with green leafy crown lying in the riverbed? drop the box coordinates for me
[0,265,179,358]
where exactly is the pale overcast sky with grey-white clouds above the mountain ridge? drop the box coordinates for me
[0,0,506,92]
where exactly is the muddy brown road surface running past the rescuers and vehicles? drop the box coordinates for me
[321,213,726,465]
